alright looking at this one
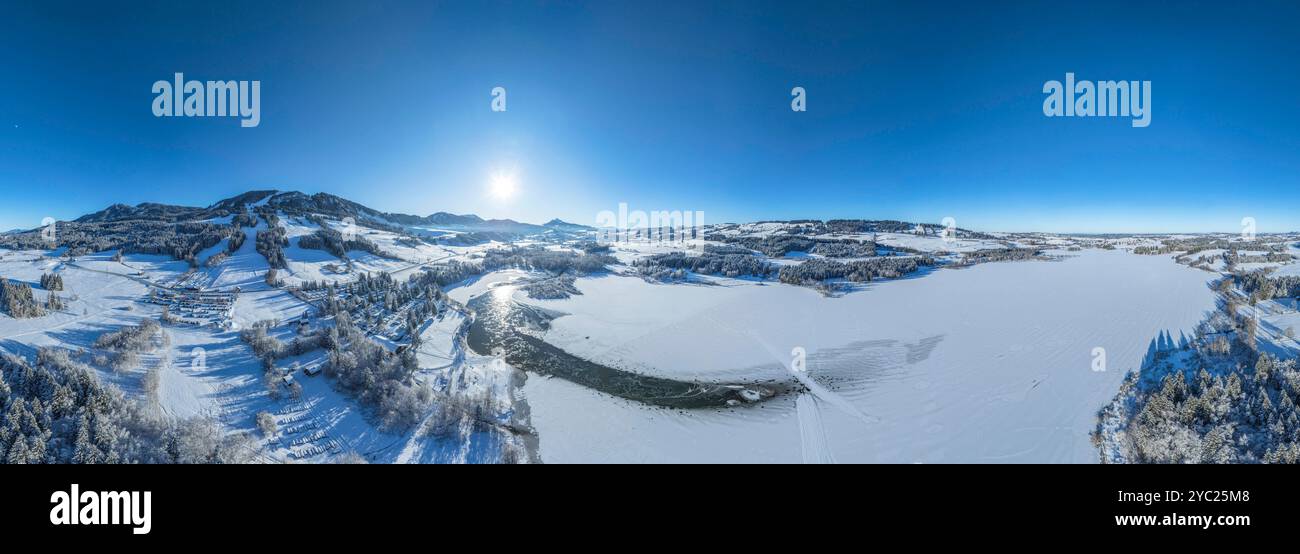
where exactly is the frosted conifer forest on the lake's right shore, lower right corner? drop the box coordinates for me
[1093,278,1300,463]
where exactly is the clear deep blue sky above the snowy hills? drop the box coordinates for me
[0,0,1300,231]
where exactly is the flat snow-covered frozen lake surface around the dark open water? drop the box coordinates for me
[516,250,1214,463]
